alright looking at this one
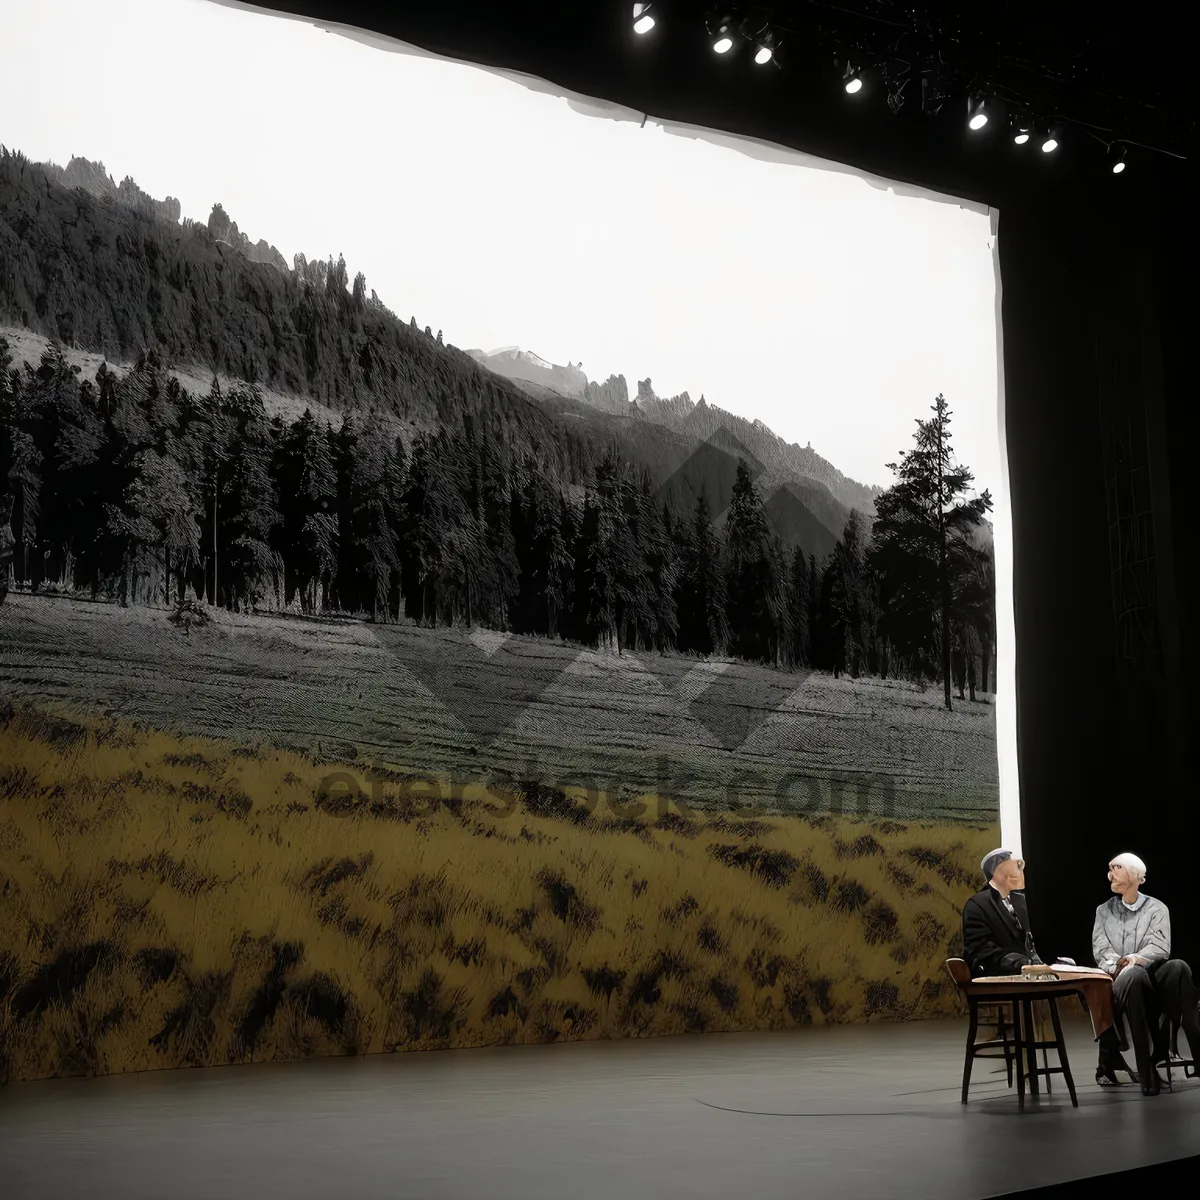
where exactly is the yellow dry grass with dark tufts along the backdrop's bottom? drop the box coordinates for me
[0,707,996,1080]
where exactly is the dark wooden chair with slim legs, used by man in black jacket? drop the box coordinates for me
[946,959,1079,1111]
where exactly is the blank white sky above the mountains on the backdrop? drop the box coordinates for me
[0,0,1000,494]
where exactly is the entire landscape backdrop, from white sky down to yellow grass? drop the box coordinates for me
[0,0,1009,1079]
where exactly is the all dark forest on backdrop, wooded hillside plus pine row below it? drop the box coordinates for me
[0,148,995,704]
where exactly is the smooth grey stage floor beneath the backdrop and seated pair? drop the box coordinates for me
[0,1020,1200,1200]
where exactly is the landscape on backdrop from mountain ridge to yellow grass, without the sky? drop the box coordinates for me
[0,142,997,1078]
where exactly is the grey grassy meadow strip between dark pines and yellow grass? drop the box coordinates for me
[0,593,998,823]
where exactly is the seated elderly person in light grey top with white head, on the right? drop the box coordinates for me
[1092,854,1200,1096]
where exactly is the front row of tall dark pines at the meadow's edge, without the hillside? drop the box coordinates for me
[0,338,995,704]
